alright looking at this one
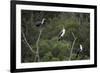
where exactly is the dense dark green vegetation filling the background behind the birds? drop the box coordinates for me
[21,10,90,62]
